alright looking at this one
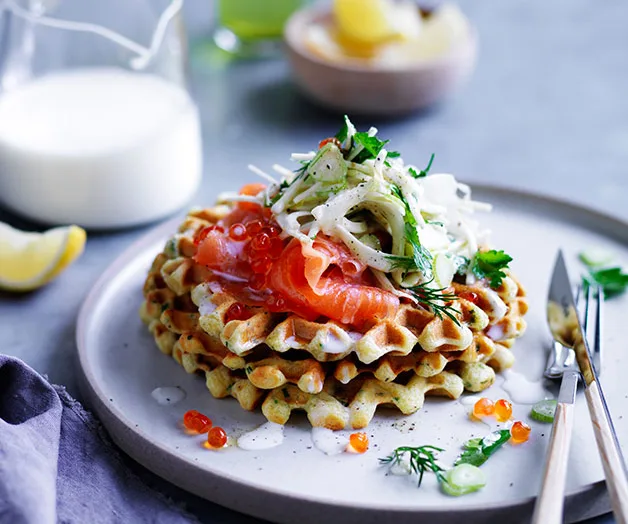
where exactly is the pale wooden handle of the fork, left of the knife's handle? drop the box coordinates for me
[532,402,574,524]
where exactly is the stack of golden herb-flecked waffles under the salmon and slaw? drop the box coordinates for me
[140,206,528,430]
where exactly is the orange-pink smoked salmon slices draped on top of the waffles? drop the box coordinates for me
[194,206,399,326]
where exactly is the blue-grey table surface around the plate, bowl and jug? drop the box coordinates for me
[0,0,628,524]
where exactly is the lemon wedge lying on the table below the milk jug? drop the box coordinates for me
[0,222,86,291]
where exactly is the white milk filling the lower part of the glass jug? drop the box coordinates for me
[0,68,201,228]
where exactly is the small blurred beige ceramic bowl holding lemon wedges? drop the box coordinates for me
[284,8,478,116]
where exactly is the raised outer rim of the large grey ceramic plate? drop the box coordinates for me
[75,182,628,522]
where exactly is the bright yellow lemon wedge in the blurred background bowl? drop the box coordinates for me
[333,0,421,46]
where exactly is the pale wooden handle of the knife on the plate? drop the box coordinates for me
[584,380,628,524]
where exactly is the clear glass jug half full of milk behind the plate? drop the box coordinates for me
[0,0,202,229]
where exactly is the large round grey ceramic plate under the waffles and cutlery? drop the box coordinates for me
[77,187,628,524]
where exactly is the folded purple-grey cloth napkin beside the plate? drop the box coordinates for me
[0,355,198,524]
